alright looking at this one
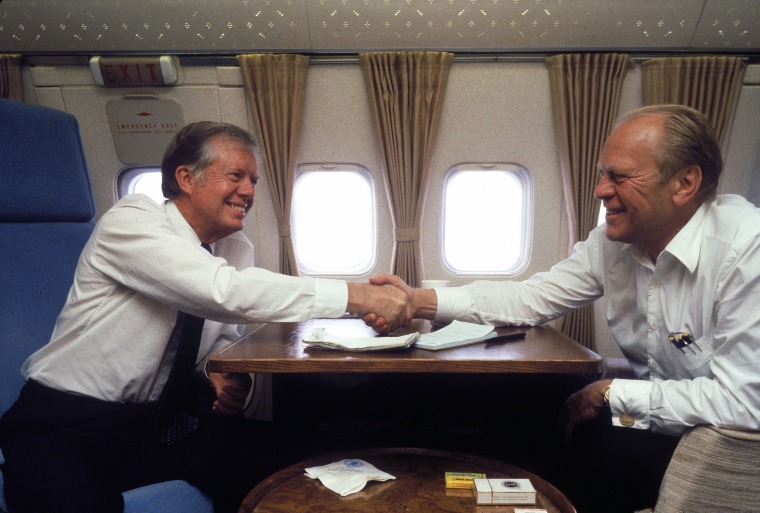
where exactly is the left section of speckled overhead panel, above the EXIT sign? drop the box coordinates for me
[0,0,310,54]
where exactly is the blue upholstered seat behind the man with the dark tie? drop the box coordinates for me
[0,98,213,513]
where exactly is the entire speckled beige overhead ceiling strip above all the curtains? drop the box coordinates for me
[0,0,760,55]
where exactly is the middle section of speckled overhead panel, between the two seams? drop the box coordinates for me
[309,0,703,51]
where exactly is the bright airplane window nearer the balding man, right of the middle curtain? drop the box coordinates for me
[443,164,532,274]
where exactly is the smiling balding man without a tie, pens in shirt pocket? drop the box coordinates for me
[365,106,760,513]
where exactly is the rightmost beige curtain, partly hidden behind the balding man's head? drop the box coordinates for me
[641,56,747,144]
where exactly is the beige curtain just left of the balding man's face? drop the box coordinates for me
[546,54,633,347]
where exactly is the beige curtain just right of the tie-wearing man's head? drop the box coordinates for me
[237,54,309,276]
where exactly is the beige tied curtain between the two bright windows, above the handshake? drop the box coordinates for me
[359,52,453,287]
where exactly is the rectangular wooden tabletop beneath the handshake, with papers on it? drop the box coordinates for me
[208,318,602,374]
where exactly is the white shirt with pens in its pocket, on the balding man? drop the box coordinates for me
[436,195,760,434]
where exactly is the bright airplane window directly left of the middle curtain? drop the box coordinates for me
[291,164,376,275]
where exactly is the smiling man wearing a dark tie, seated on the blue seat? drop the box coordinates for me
[0,122,406,513]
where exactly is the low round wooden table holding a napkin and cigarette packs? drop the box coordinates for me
[239,449,575,513]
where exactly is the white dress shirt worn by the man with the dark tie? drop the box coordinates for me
[22,194,348,403]
